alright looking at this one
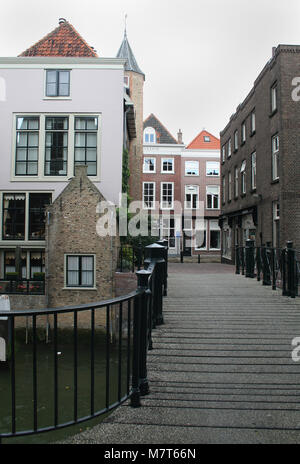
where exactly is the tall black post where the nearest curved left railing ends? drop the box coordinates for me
[136,270,151,396]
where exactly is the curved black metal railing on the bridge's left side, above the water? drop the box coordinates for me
[0,244,167,441]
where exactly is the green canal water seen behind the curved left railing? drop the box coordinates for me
[0,331,131,444]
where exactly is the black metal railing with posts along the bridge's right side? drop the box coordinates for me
[235,240,300,298]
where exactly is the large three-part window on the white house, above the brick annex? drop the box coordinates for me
[12,113,100,181]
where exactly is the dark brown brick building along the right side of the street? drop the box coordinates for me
[220,45,300,262]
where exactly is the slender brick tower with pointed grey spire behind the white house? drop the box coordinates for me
[116,27,145,200]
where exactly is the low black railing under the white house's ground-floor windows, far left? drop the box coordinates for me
[0,279,45,295]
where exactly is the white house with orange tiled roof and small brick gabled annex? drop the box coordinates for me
[0,19,130,308]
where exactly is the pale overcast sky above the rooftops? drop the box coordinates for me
[0,0,300,143]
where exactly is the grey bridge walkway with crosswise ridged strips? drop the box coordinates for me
[61,263,300,444]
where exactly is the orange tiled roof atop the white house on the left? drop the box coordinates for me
[19,18,98,57]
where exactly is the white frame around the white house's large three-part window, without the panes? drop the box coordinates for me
[10,112,102,182]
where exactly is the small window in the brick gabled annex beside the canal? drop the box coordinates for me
[65,255,95,288]
